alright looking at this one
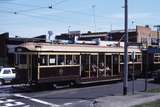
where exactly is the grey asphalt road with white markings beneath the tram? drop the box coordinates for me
[0,79,160,107]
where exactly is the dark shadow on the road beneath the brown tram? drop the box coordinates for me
[9,81,120,94]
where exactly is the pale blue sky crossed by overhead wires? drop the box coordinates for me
[0,0,160,37]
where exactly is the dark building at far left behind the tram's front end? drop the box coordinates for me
[0,33,46,66]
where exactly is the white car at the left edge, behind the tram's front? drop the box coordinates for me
[0,68,16,85]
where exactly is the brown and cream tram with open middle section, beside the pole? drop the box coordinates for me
[15,42,142,84]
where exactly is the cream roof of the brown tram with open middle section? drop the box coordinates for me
[17,42,141,52]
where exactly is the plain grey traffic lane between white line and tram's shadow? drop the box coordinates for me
[19,80,160,105]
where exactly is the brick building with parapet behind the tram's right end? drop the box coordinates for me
[109,26,158,48]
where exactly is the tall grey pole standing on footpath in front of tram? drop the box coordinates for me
[123,0,128,95]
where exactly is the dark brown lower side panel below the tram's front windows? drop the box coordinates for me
[38,66,79,83]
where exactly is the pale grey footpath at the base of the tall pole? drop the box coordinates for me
[93,92,160,107]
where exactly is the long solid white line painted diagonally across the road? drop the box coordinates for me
[14,94,60,107]
